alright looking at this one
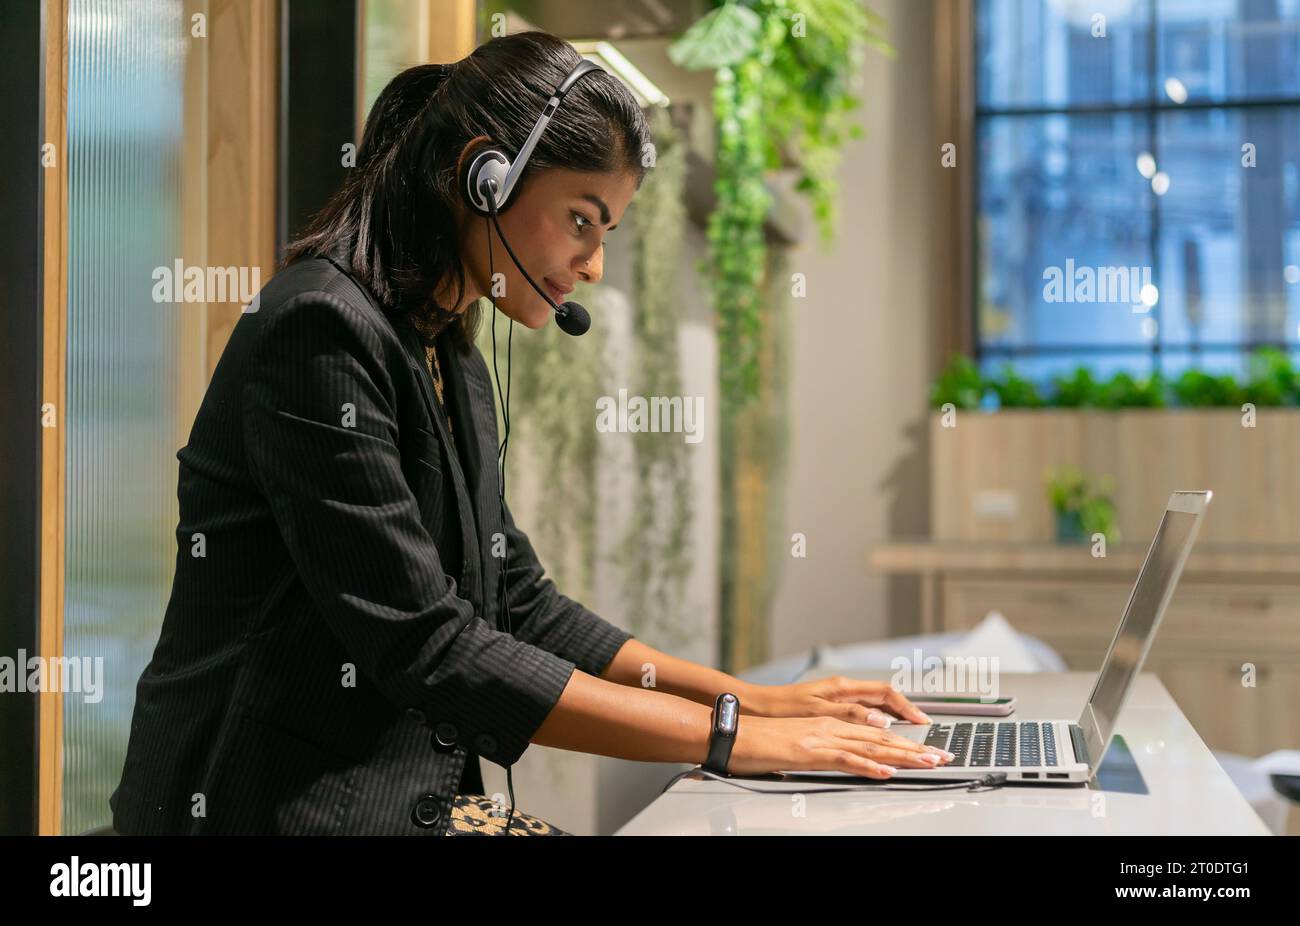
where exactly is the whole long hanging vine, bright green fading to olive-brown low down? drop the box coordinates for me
[668,0,893,671]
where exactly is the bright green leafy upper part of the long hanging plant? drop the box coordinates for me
[668,0,894,414]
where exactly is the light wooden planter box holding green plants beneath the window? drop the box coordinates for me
[930,407,1300,544]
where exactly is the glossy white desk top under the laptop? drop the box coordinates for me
[615,668,1269,836]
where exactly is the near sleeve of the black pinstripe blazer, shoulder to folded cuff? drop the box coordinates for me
[243,293,576,766]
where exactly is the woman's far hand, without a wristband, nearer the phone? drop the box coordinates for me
[740,675,932,727]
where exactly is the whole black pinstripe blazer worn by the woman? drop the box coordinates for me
[109,254,632,835]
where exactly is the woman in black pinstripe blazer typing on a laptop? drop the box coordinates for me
[111,33,944,835]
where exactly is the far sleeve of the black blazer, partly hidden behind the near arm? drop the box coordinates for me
[506,496,633,675]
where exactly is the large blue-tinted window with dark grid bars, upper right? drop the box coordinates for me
[974,0,1300,381]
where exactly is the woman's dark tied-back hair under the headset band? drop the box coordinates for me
[281,33,650,349]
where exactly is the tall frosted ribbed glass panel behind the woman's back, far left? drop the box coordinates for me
[62,0,193,834]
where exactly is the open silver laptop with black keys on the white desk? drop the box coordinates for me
[788,492,1212,783]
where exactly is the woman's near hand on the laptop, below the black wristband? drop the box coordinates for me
[727,714,953,778]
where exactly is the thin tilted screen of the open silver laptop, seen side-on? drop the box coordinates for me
[1079,507,1199,766]
